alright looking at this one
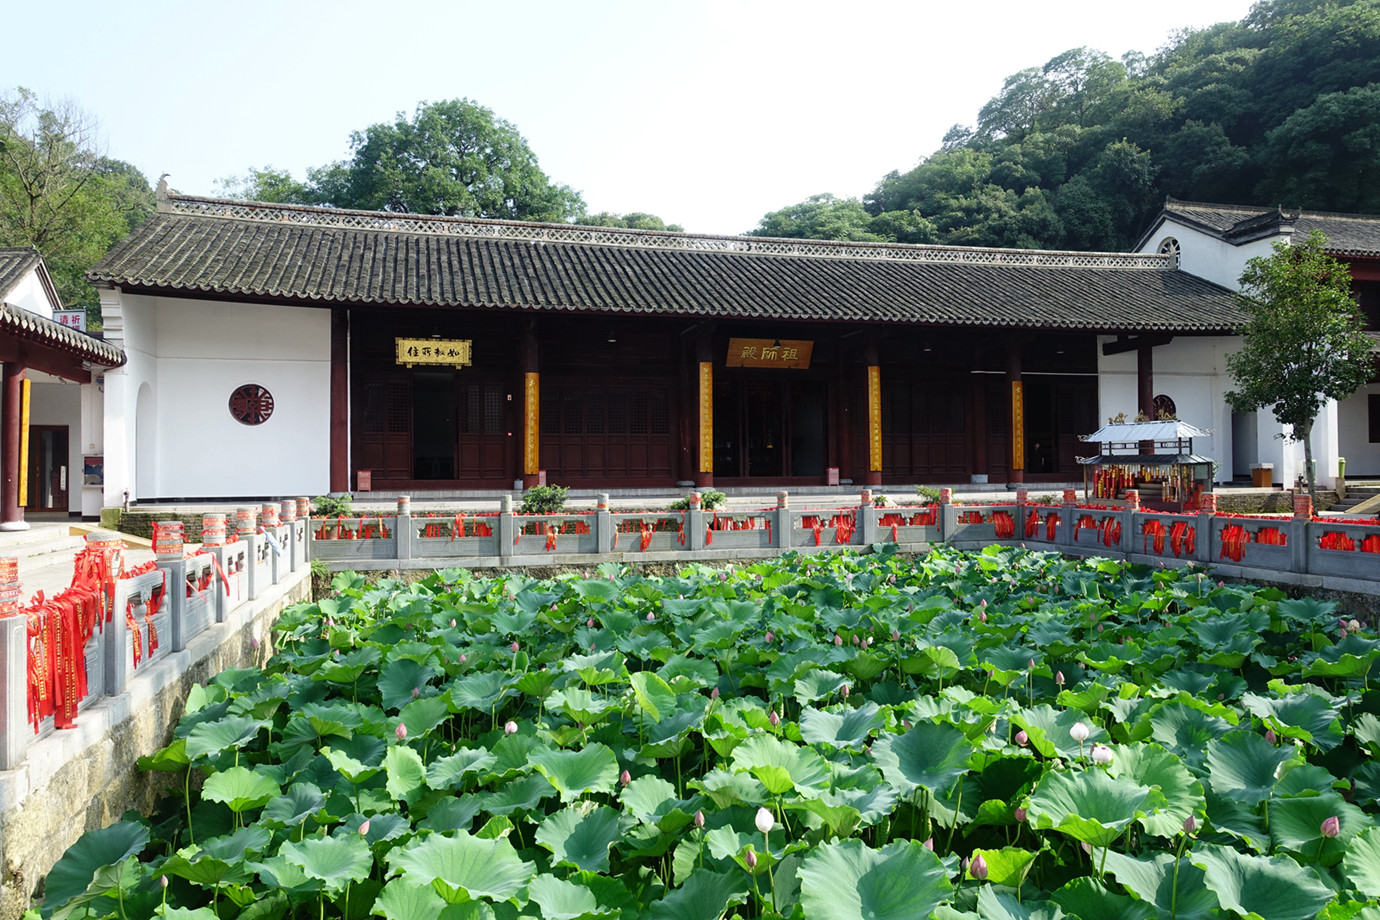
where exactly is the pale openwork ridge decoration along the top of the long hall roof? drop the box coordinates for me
[159,193,1173,270]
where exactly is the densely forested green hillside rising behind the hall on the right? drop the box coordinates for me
[753,0,1380,250]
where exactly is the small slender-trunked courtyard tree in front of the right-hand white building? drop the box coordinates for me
[1227,230,1374,503]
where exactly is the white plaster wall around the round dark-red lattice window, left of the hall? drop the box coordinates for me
[134,295,331,498]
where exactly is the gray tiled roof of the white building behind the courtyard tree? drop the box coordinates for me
[1161,199,1380,257]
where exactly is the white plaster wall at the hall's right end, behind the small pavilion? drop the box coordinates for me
[1097,335,1239,483]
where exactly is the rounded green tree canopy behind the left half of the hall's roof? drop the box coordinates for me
[221,99,585,222]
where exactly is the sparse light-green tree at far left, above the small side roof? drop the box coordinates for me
[0,88,153,328]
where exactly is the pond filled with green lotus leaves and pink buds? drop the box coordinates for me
[43,546,1380,920]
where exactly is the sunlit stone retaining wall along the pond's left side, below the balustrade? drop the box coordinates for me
[0,567,311,920]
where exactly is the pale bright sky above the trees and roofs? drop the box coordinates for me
[8,0,1252,233]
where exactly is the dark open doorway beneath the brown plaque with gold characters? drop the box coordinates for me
[713,378,828,480]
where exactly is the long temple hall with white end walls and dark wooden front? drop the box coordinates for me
[88,193,1241,503]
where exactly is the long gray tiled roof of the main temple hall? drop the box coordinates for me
[87,196,1241,331]
